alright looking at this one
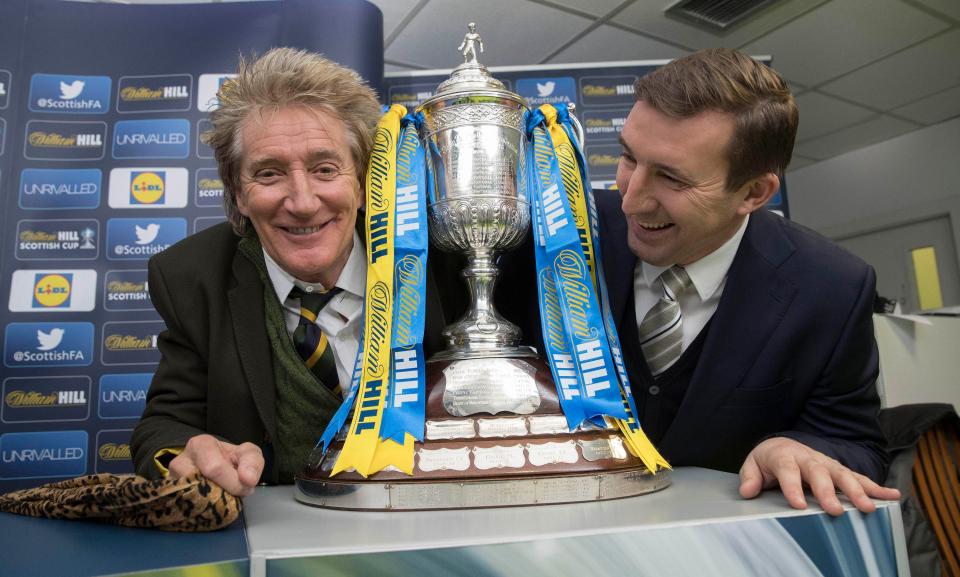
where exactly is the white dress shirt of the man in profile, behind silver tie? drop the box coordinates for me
[633,215,750,351]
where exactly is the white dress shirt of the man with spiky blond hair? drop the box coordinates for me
[263,231,367,390]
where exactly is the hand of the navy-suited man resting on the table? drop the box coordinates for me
[740,437,900,515]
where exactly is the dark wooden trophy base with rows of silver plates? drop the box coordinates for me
[295,354,670,510]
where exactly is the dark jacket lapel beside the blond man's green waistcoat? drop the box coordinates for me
[227,251,277,438]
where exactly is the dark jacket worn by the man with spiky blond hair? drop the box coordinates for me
[130,223,444,482]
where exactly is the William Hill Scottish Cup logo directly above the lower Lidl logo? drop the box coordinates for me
[16,219,100,260]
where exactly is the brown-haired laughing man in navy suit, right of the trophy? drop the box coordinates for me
[597,49,898,514]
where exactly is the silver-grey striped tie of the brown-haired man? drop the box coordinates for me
[639,266,690,376]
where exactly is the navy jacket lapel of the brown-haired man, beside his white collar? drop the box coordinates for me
[661,209,797,452]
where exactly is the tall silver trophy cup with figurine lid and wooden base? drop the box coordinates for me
[295,23,670,510]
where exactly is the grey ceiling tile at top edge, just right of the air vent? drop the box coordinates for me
[743,0,949,85]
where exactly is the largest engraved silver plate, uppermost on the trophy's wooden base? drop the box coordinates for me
[443,358,540,417]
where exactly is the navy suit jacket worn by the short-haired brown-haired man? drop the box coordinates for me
[595,191,888,481]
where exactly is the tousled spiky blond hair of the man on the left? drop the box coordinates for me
[203,48,380,235]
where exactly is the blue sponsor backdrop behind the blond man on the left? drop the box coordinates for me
[0,0,383,491]
